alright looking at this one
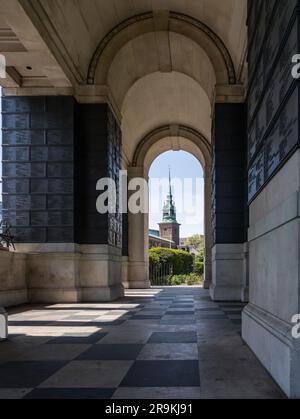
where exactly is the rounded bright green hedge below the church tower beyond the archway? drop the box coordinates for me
[149,247,194,275]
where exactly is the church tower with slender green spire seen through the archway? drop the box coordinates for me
[159,170,180,246]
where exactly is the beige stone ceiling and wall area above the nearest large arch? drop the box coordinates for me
[0,0,247,91]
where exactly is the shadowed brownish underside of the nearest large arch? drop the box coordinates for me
[106,32,217,109]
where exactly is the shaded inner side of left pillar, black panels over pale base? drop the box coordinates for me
[75,104,123,301]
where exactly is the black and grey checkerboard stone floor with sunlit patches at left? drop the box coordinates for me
[0,287,282,399]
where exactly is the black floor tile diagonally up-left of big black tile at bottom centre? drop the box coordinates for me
[77,344,144,361]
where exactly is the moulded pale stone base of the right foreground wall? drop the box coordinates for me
[242,304,300,398]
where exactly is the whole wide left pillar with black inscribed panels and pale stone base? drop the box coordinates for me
[2,96,123,302]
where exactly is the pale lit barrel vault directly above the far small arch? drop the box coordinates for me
[121,72,211,166]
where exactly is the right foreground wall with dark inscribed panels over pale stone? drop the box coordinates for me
[243,0,300,398]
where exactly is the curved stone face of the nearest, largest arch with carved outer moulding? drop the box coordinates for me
[87,11,237,85]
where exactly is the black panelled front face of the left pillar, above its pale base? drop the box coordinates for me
[2,97,75,243]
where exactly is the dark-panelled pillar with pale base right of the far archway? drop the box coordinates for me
[210,103,246,301]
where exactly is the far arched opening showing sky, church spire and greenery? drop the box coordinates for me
[145,151,205,286]
